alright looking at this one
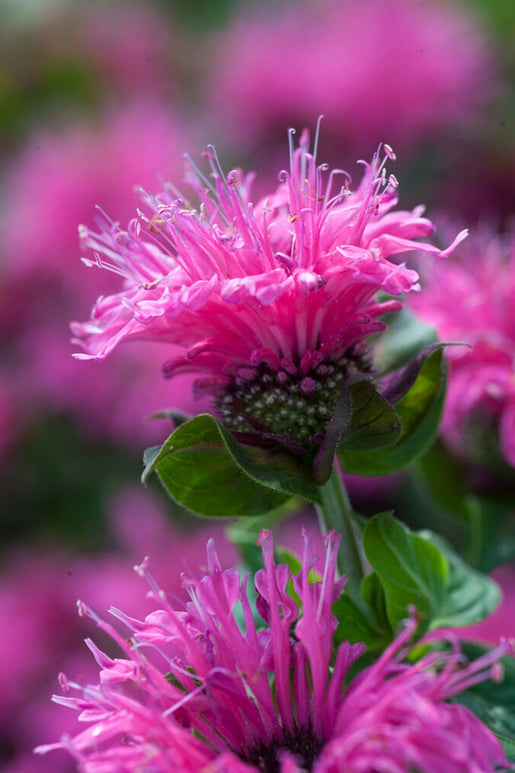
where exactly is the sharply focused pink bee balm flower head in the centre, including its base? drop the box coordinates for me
[72,132,463,453]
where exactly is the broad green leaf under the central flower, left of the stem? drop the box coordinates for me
[142,414,318,517]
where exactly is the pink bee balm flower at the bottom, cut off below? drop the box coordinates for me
[37,531,509,773]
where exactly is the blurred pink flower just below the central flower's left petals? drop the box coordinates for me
[14,324,204,450]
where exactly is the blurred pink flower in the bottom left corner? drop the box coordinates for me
[0,545,94,773]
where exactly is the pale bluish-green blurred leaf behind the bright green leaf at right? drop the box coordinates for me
[419,531,501,629]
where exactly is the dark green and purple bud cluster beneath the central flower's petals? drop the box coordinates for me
[215,342,373,450]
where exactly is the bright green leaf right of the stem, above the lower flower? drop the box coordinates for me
[363,513,449,630]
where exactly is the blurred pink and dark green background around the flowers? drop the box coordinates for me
[0,0,515,773]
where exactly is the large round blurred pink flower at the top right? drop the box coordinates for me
[207,0,496,153]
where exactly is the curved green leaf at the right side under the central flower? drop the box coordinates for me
[338,349,445,475]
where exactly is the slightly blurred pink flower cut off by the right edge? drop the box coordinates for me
[412,230,515,467]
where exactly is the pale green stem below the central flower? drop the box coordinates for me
[316,466,365,607]
